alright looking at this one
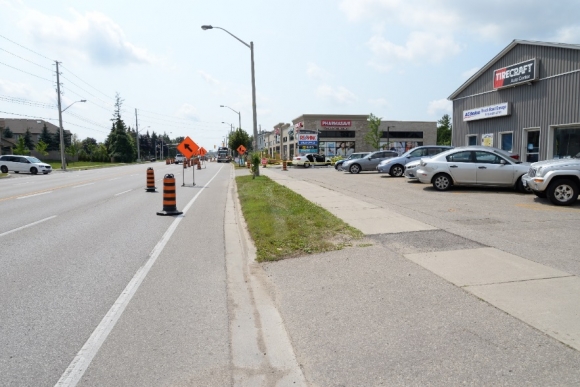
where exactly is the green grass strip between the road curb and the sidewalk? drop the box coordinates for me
[236,176,363,262]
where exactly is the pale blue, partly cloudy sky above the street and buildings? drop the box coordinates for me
[0,0,580,149]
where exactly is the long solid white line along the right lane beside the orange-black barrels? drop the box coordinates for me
[55,166,223,387]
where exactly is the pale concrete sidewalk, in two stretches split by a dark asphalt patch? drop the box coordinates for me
[260,168,580,350]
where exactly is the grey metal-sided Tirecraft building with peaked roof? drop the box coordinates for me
[449,40,580,162]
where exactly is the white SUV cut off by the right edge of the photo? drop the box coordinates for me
[522,153,580,206]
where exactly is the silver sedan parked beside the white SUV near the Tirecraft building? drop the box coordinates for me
[416,146,531,192]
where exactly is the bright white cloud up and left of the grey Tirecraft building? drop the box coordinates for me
[367,32,461,69]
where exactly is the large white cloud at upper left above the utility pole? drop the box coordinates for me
[18,9,155,65]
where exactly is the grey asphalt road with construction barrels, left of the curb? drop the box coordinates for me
[0,163,231,386]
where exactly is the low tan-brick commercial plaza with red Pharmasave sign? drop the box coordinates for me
[258,114,437,159]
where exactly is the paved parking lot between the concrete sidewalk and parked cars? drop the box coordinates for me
[278,167,580,276]
